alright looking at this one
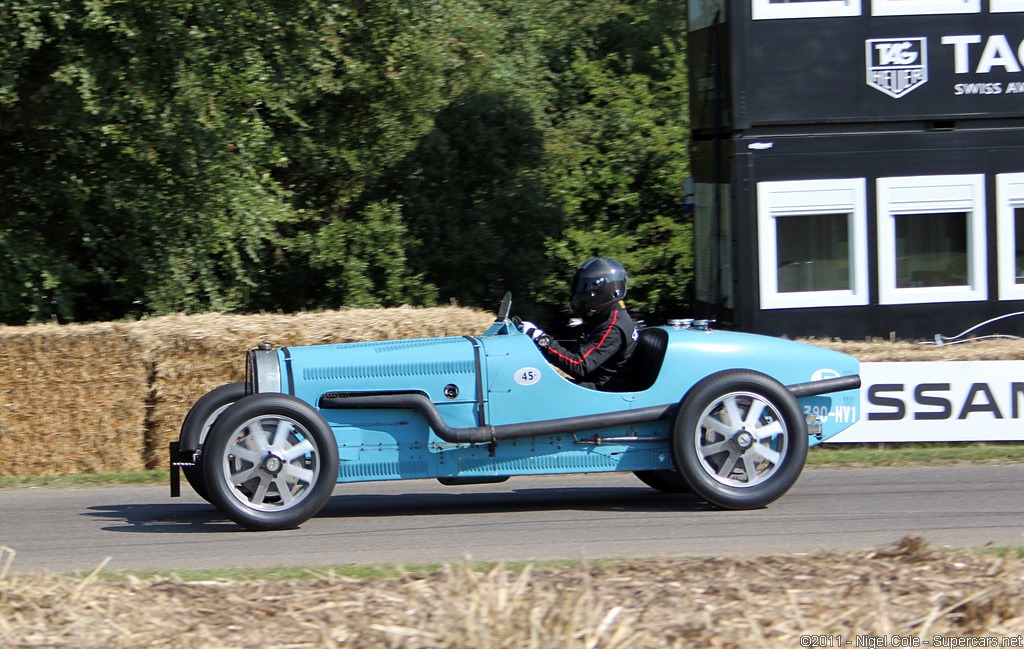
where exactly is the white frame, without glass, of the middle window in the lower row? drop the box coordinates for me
[877,174,988,304]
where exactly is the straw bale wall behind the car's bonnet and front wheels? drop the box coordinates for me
[0,307,494,476]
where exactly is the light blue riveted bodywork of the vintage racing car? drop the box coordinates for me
[260,320,859,482]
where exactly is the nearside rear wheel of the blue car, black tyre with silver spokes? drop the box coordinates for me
[672,370,807,510]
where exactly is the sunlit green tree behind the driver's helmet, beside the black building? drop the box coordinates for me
[546,0,692,322]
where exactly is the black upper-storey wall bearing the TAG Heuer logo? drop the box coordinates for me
[688,0,1024,132]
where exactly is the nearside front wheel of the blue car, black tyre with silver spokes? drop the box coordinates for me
[203,393,338,530]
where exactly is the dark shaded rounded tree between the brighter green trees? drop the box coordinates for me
[370,91,561,305]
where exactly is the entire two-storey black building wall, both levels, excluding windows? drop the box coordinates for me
[688,0,1024,339]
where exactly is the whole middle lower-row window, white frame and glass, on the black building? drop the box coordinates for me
[878,174,988,304]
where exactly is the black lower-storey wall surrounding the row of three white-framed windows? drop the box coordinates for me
[731,128,1024,339]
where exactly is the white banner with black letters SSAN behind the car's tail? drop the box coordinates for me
[827,360,1024,443]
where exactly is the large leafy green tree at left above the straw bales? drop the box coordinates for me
[0,0,472,322]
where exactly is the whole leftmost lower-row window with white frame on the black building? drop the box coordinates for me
[758,178,867,309]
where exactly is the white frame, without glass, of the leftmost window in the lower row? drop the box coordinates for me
[758,178,868,309]
